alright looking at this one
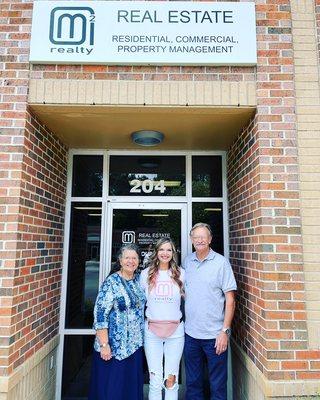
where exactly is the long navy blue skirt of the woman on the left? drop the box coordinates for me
[88,347,143,400]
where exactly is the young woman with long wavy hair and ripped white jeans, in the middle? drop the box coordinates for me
[140,238,184,400]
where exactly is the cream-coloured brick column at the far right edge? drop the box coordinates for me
[293,0,320,348]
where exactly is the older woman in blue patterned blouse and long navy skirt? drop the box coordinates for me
[89,245,145,400]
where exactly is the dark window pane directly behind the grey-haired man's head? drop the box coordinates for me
[192,203,224,254]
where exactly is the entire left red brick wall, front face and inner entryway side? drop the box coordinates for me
[0,1,66,376]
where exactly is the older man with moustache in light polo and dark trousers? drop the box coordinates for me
[184,223,237,400]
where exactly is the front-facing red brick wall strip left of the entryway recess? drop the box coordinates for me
[0,2,31,375]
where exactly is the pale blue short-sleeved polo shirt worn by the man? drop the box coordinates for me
[183,249,237,339]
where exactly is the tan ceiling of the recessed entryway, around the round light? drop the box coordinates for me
[30,104,255,150]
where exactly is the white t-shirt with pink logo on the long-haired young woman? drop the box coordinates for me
[140,268,184,334]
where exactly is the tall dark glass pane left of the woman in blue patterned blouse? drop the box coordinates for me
[66,203,102,328]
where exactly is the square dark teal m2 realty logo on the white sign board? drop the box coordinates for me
[49,7,95,55]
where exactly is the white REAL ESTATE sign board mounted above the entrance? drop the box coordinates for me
[30,0,257,65]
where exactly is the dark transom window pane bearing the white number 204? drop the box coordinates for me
[109,156,186,196]
